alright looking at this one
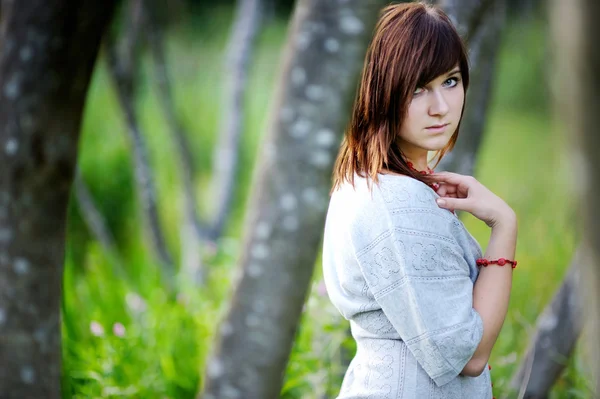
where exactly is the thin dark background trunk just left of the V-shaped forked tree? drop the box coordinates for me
[106,0,175,288]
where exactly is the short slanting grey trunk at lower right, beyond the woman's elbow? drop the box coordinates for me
[510,248,584,399]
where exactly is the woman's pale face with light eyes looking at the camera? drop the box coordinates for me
[398,66,465,160]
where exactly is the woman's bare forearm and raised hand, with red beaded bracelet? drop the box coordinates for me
[428,172,517,377]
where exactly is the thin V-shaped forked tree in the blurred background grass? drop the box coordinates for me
[143,0,264,285]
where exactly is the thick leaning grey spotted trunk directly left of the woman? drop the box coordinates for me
[203,0,387,399]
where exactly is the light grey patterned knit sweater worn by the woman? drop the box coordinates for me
[323,175,492,399]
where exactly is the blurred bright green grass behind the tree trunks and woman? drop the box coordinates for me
[63,10,589,399]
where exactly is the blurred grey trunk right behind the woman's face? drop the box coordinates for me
[438,0,506,175]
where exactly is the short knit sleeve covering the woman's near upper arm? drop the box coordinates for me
[353,193,483,386]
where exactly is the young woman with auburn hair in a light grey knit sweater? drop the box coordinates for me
[323,3,517,399]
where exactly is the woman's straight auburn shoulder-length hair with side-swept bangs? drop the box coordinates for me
[332,3,469,192]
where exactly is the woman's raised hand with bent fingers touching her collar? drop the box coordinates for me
[430,172,516,228]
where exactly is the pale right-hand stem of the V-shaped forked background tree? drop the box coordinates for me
[210,0,264,240]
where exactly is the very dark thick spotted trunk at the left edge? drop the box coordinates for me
[0,0,114,399]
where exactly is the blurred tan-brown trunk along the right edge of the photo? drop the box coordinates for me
[550,0,600,394]
